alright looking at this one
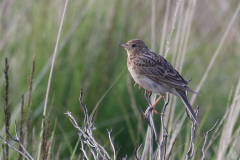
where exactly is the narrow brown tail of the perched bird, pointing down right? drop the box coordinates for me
[176,89,200,124]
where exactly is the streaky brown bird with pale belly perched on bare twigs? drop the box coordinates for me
[119,39,200,124]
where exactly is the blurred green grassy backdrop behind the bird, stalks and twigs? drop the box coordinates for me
[0,0,240,159]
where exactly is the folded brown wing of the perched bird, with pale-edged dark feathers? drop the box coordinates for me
[132,51,198,94]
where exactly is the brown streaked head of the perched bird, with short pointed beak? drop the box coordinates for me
[119,39,148,56]
